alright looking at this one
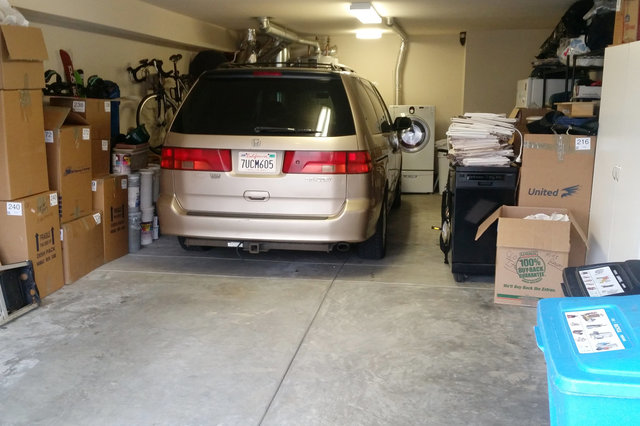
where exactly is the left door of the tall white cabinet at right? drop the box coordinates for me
[587,44,631,263]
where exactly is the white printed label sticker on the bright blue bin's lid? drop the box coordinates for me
[564,309,626,354]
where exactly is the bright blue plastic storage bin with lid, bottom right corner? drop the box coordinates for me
[535,295,640,426]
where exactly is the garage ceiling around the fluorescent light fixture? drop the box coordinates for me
[143,0,575,36]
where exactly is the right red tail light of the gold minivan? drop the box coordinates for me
[282,151,371,174]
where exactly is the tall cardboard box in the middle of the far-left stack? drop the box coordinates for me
[0,90,49,200]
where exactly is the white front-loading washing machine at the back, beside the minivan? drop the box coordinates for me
[389,105,436,193]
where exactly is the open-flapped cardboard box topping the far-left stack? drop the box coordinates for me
[0,25,48,90]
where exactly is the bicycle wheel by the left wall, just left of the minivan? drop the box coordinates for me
[136,93,178,153]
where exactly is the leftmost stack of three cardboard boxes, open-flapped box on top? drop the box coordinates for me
[0,26,64,297]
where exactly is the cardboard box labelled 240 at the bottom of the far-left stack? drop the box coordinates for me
[0,191,64,297]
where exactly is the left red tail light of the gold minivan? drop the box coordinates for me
[160,147,231,172]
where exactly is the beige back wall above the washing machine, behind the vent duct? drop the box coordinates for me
[331,30,551,139]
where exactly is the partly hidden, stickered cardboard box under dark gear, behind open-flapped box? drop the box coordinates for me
[49,96,111,141]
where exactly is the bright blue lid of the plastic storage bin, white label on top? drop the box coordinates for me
[535,295,640,398]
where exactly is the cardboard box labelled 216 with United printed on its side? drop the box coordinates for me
[518,134,596,266]
